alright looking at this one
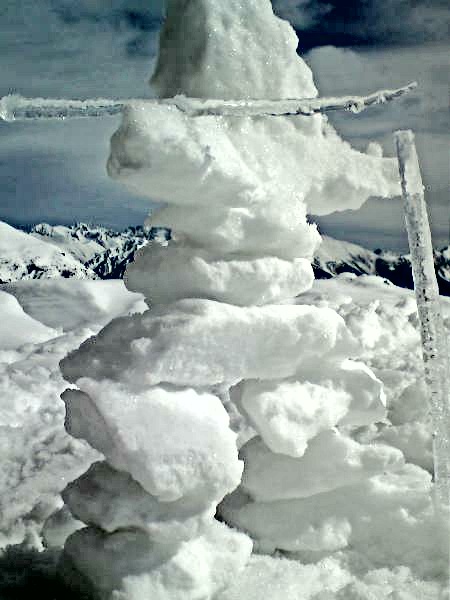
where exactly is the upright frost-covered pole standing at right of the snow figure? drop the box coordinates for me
[394,130,450,510]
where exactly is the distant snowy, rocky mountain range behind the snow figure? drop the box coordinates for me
[0,223,450,296]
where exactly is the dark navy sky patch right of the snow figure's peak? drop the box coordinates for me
[274,0,450,50]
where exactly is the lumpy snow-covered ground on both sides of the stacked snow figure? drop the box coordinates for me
[0,274,450,600]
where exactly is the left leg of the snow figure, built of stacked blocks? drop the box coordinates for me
[58,372,252,600]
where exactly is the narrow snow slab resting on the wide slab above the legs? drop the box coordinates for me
[125,241,314,306]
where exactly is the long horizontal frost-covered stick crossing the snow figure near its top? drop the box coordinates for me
[0,82,417,121]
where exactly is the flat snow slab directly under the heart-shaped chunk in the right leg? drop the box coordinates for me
[240,430,404,502]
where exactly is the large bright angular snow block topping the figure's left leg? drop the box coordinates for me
[63,378,243,510]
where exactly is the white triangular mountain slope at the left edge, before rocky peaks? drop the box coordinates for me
[0,221,96,283]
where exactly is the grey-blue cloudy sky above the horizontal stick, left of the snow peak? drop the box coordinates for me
[0,0,162,98]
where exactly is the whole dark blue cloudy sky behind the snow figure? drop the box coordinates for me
[0,0,450,251]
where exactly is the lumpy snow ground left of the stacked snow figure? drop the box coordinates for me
[0,279,145,547]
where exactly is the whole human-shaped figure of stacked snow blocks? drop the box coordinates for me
[61,0,412,600]
